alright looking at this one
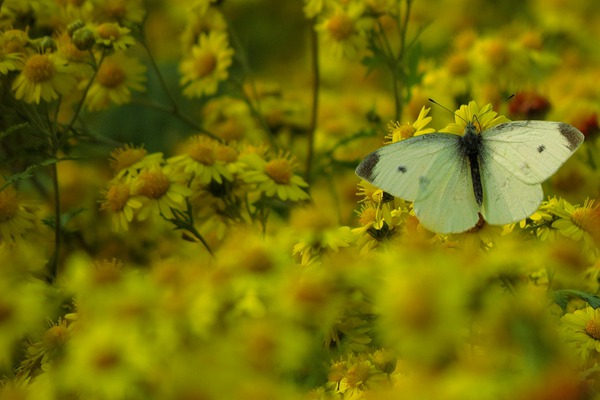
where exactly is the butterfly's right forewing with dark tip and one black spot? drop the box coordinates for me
[482,121,584,184]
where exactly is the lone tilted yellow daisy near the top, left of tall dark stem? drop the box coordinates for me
[180,31,233,97]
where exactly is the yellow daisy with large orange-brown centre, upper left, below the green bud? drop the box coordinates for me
[12,53,77,103]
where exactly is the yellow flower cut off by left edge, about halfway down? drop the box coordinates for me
[0,186,35,243]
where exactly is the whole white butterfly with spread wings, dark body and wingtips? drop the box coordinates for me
[356,121,583,233]
